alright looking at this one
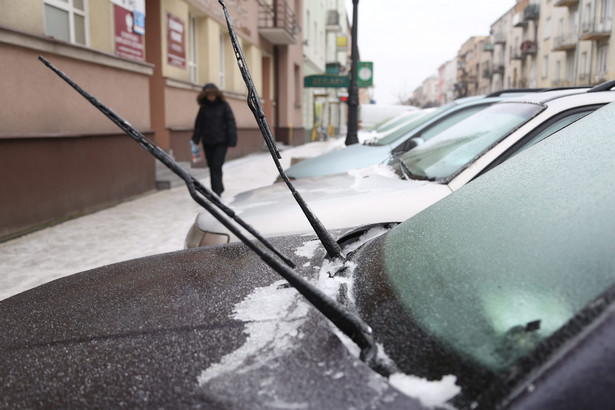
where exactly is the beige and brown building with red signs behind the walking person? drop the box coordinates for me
[0,0,305,239]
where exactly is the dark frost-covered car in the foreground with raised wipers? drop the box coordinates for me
[0,104,615,409]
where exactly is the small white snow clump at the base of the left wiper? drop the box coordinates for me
[389,373,461,408]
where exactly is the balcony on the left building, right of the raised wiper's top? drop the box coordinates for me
[258,0,301,45]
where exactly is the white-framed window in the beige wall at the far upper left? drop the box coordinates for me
[44,0,89,46]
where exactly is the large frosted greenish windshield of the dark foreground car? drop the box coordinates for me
[382,104,615,371]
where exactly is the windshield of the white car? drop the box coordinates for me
[391,103,544,180]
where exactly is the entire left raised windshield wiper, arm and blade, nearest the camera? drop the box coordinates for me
[38,56,391,376]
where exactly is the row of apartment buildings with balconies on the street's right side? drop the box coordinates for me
[430,0,615,100]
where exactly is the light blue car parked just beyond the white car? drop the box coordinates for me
[285,96,510,179]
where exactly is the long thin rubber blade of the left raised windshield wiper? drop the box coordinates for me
[38,56,295,267]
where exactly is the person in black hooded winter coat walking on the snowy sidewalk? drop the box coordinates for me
[192,83,237,196]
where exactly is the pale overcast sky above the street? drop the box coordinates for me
[345,0,516,104]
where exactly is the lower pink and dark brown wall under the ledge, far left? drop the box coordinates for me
[0,28,155,239]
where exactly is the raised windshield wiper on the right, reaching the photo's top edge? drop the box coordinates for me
[218,0,342,258]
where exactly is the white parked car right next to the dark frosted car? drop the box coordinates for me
[185,84,615,248]
